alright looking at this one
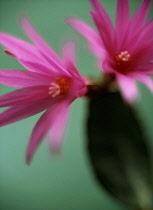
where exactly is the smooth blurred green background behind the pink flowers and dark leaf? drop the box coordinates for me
[0,0,153,210]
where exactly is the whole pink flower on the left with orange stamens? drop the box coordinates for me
[0,18,87,164]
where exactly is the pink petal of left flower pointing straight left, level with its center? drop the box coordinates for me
[0,69,53,88]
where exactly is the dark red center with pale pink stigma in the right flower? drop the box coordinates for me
[115,51,131,69]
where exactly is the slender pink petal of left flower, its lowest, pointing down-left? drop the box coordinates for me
[26,103,65,164]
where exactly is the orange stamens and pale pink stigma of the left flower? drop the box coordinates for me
[49,77,70,98]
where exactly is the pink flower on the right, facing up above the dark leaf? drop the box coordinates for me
[67,0,153,102]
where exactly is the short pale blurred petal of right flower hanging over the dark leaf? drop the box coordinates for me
[117,74,138,103]
